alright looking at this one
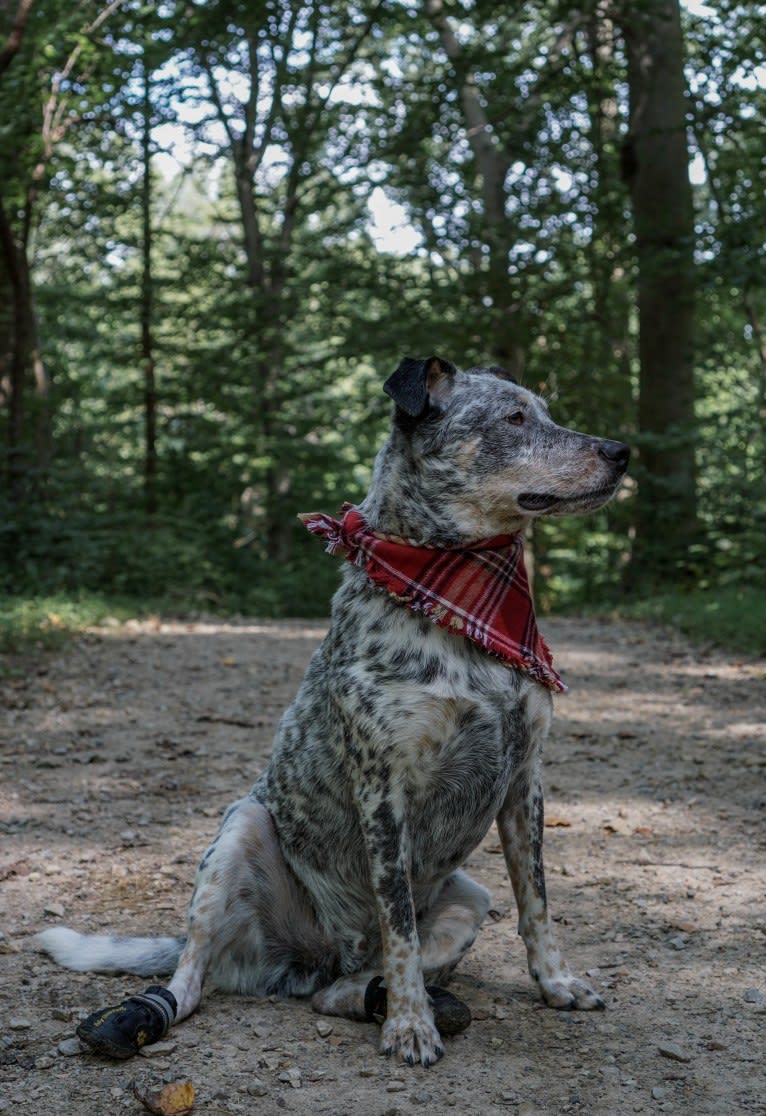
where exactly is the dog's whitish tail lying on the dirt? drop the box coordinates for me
[36,926,185,977]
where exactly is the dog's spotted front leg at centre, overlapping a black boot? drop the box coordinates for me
[360,788,444,1066]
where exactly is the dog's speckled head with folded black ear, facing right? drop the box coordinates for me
[383,356,630,538]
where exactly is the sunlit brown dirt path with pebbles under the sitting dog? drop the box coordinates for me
[0,619,766,1116]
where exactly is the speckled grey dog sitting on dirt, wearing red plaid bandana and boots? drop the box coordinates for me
[39,357,630,1066]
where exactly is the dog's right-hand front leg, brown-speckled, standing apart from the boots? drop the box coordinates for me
[497,759,604,1011]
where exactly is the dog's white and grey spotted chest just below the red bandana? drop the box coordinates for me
[331,595,550,873]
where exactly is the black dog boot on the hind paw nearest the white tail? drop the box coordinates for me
[77,984,178,1058]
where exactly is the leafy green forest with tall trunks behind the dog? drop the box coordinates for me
[0,0,766,651]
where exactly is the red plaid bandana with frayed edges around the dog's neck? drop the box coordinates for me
[298,504,566,693]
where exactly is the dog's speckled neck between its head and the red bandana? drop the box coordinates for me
[358,432,528,547]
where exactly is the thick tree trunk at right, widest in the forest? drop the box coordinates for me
[623,0,697,581]
